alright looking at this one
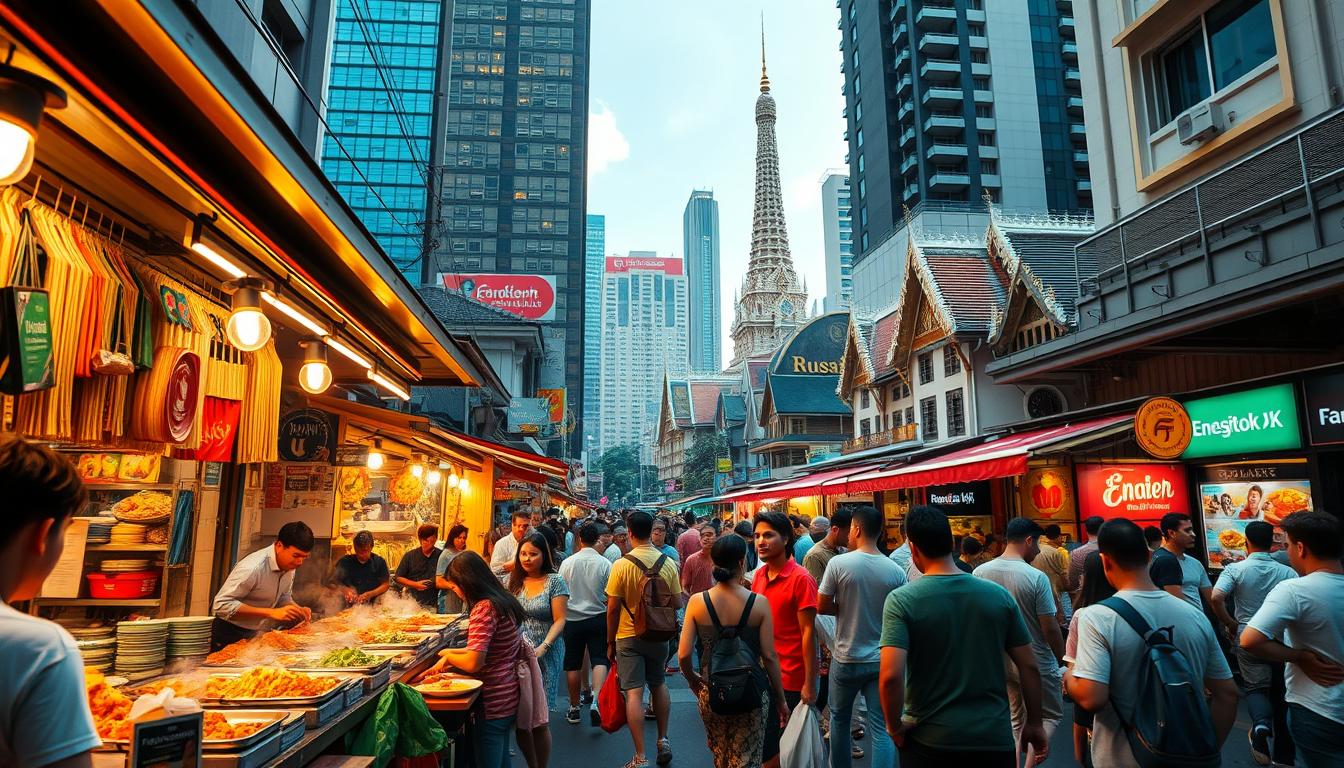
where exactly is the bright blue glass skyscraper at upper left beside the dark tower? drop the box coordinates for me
[321,0,444,277]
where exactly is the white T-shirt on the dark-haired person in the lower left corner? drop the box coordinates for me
[0,603,102,765]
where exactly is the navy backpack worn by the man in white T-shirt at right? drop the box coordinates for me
[1101,597,1222,768]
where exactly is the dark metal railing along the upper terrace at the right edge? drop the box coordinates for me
[1074,109,1344,299]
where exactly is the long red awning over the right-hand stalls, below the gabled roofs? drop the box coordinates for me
[836,416,1133,494]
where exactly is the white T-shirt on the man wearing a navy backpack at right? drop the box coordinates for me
[1074,589,1232,768]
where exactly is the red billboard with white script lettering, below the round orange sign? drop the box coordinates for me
[1075,464,1189,535]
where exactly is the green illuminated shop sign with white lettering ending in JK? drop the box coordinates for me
[1181,383,1302,459]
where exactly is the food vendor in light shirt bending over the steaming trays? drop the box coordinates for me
[210,521,313,652]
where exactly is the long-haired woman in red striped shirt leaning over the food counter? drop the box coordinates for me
[426,551,524,768]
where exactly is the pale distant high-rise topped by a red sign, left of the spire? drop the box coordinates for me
[598,250,688,455]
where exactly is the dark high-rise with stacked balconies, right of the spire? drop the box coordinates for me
[839,0,1093,308]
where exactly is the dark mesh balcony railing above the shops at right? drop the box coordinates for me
[1074,109,1344,325]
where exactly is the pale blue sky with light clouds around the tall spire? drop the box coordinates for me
[587,0,845,364]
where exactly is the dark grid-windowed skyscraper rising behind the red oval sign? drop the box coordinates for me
[437,0,590,456]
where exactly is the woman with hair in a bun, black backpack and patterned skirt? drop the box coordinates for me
[677,535,789,768]
